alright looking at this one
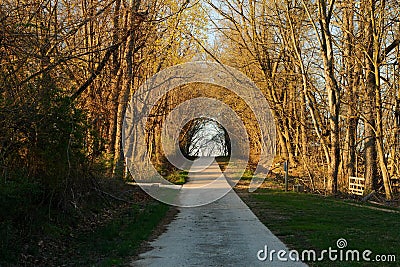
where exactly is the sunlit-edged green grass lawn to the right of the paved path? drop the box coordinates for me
[245,190,400,266]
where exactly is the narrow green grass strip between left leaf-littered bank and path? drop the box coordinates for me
[63,201,169,266]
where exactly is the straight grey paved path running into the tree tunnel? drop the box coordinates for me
[131,158,306,267]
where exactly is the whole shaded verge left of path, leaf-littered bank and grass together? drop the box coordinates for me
[0,180,176,267]
